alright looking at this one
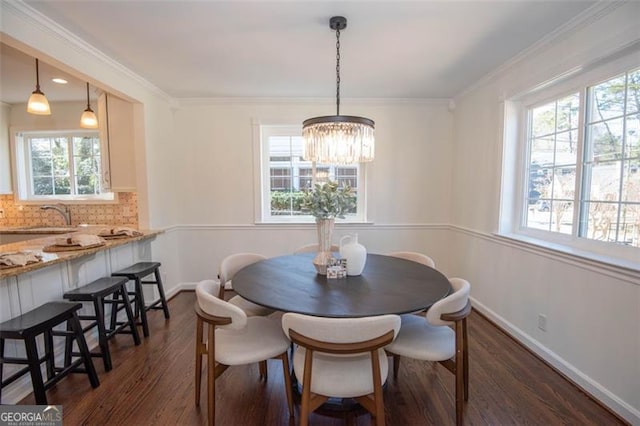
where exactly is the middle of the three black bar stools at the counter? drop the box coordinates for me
[64,277,140,371]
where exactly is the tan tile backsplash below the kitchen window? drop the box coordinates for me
[0,192,138,227]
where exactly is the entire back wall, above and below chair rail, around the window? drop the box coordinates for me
[171,100,452,281]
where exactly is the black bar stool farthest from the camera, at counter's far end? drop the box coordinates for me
[111,262,169,337]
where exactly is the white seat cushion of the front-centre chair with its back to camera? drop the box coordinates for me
[293,347,389,398]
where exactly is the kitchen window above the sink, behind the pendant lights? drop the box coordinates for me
[14,131,113,201]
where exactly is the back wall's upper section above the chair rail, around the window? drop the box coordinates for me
[171,101,452,224]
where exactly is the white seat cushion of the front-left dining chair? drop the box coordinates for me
[216,317,290,365]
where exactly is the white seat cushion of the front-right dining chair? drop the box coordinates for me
[385,315,456,361]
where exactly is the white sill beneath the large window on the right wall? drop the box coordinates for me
[493,233,640,273]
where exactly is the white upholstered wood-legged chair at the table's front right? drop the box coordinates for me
[385,278,471,425]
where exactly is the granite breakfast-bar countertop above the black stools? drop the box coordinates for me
[0,226,164,279]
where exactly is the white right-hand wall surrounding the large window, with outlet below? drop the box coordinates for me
[451,2,640,424]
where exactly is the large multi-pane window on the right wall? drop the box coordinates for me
[519,64,640,259]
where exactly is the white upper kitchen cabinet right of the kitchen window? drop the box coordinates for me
[98,93,136,192]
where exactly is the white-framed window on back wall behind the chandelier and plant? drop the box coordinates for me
[259,125,365,222]
